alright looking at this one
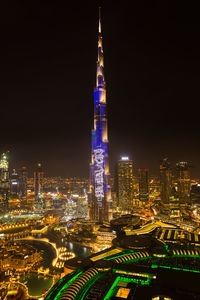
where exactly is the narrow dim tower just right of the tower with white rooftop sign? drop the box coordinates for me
[138,169,149,205]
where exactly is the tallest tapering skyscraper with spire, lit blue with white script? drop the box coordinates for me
[88,10,112,222]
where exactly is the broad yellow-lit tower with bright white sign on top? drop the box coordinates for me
[117,156,133,211]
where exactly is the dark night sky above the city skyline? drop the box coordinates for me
[0,0,200,177]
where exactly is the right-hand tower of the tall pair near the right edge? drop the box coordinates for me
[176,162,190,204]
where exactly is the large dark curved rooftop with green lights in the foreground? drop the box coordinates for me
[46,235,200,300]
